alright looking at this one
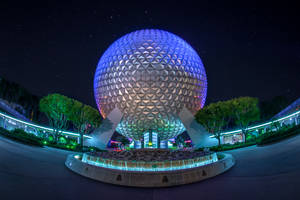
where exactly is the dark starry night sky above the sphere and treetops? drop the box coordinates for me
[0,1,300,106]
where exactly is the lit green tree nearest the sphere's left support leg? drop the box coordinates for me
[69,100,102,149]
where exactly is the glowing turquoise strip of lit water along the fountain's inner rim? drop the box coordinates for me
[81,153,218,172]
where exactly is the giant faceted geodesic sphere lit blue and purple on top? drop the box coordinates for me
[94,29,207,140]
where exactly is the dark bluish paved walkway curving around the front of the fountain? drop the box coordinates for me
[0,135,300,200]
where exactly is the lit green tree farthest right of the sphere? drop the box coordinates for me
[231,97,260,142]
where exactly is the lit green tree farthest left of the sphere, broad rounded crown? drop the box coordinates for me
[39,94,73,137]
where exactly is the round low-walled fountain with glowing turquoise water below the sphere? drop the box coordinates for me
[65,149,235,187]
